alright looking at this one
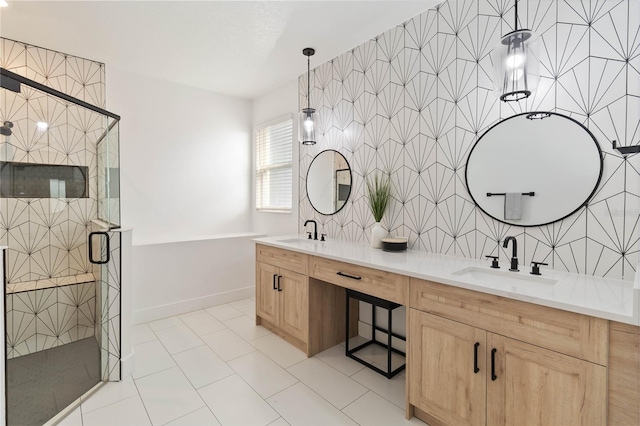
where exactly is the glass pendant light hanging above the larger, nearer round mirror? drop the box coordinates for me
[493,0,540,102]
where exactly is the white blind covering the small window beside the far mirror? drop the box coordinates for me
[256,117,293,211]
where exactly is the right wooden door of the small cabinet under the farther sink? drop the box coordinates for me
[277,269,309,343]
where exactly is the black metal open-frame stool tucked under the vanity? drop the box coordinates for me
[345,289,407,379]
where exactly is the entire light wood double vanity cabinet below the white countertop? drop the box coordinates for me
[256,244,640,426]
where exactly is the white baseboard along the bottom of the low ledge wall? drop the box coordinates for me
[133,286,256,324]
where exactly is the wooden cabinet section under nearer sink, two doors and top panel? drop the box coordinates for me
[408,280,608,426]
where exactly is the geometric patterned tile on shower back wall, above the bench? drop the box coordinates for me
[0,38,106,283]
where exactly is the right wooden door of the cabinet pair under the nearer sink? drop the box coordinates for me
[487,334,607,426]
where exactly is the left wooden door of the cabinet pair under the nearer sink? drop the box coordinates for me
[407,309,487,426]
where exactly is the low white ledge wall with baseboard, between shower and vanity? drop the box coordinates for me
[132,232,263,324]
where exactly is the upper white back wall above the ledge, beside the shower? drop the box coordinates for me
[107,67,252,245]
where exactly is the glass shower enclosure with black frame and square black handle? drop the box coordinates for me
[0,68,120,425]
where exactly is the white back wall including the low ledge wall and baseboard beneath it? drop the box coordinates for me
[107,67,255,323]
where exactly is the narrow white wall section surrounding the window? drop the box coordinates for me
[251,80,299,235]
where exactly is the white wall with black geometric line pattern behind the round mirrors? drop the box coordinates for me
[298,0,640,279]
